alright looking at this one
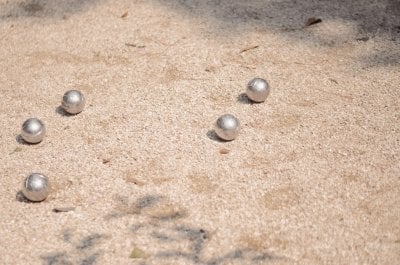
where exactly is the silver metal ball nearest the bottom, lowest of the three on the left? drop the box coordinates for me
[22,173,50,202]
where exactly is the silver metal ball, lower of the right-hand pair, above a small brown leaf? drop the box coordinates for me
[215,114,240,141]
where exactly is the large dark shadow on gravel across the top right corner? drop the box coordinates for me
[152,0,400,66]
